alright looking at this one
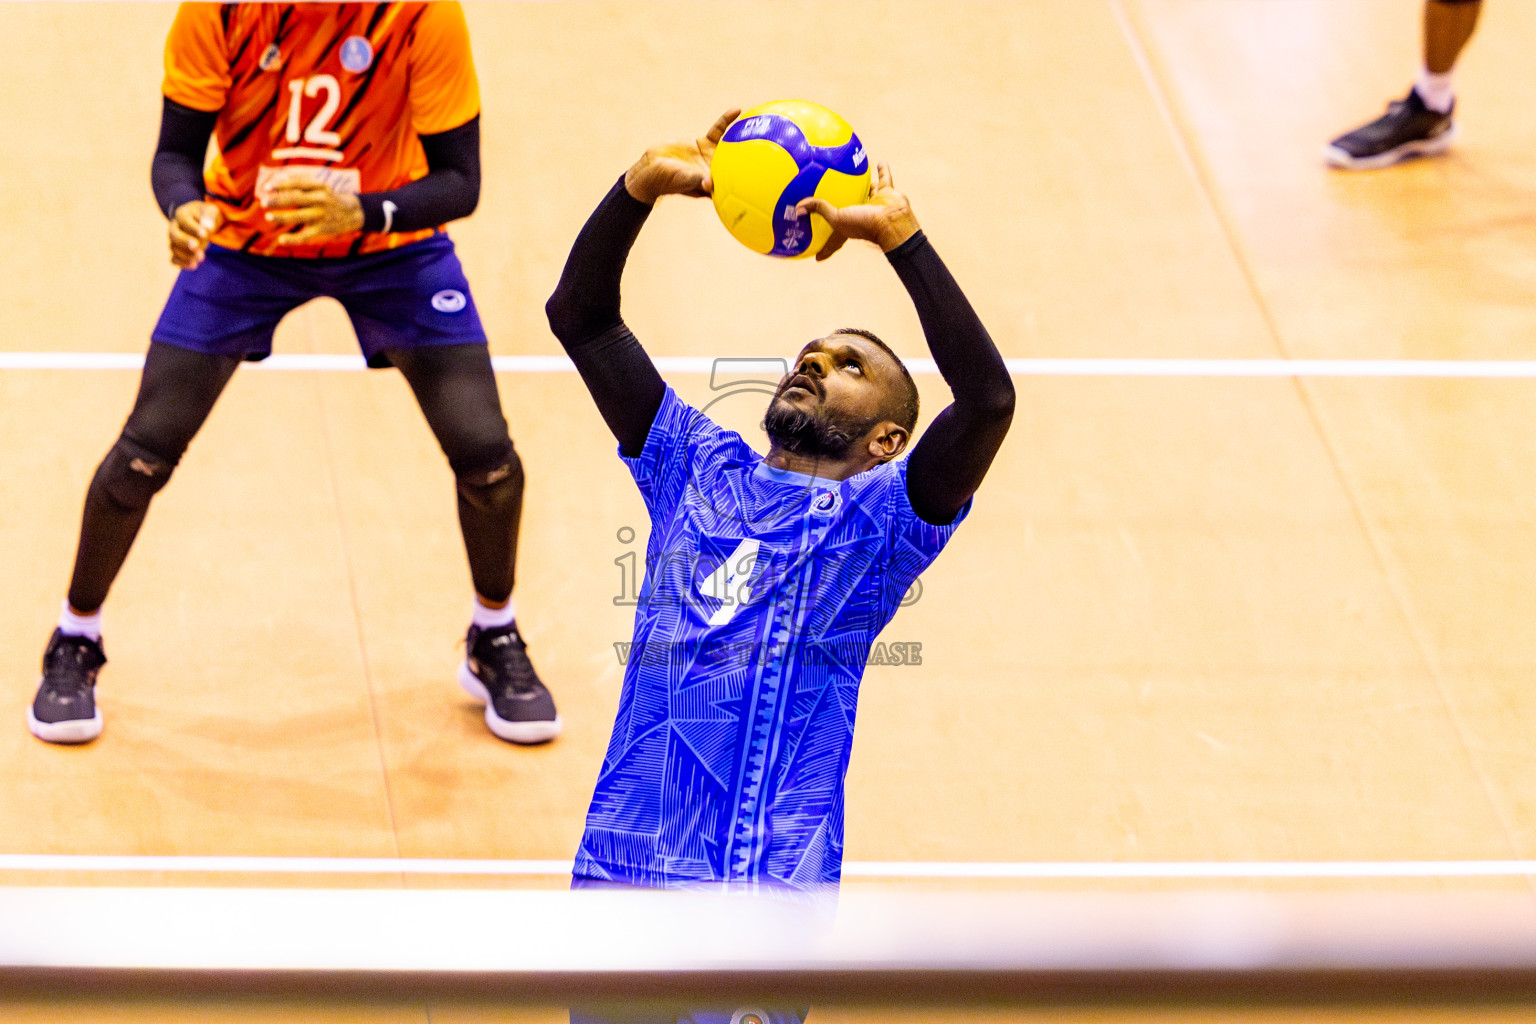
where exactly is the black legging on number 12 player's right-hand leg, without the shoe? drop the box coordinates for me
[389,345,522,602]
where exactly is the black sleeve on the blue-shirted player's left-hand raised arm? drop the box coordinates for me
[544,178,667,457]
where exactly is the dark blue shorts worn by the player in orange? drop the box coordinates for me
[151,232,485,367]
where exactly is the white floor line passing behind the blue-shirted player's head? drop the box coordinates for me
[9,352,1536,379]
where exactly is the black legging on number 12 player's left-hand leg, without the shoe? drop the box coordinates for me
[69,342,240,613]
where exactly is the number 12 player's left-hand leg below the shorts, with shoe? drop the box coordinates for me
[26,342,240,743]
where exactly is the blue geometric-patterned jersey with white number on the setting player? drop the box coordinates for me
[576,388,969,892]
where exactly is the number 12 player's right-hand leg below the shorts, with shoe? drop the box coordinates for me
[389,344,561,743]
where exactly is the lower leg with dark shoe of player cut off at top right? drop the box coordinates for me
[1322,0,1482,170]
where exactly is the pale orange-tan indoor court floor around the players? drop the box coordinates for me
[0,0,1536,1024]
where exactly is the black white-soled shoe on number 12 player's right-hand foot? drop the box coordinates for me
[459,623,561,743]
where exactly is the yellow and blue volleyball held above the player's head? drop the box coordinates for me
[710,100,869,259]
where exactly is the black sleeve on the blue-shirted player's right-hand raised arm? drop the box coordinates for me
[889,232,1014,525]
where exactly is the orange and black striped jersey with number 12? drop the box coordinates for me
[164,0,479,256]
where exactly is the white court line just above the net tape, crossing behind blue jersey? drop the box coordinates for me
[0,854,1536,881]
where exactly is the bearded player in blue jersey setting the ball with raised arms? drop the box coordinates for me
[547,111,1014,1024]
